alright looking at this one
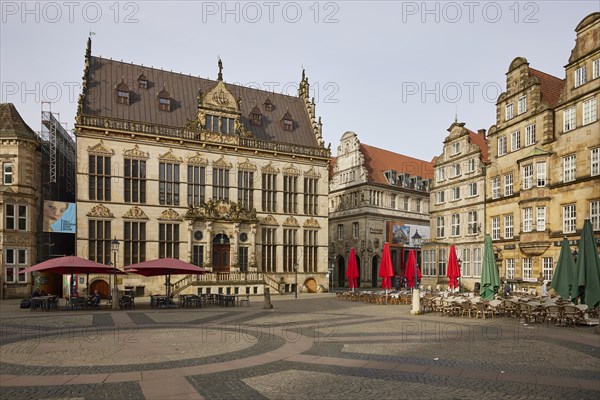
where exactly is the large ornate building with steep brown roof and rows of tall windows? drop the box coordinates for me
[76,42,330,294]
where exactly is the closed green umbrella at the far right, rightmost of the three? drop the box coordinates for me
[573,219,600,308]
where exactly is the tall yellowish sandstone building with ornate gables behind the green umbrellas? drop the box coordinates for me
[486,13,600,288]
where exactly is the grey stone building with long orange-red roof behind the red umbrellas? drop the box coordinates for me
[329,132,433,287]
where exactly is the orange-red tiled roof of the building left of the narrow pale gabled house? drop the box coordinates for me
[360,143,433,185]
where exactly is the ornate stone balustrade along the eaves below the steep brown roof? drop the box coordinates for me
[81,115,330,158]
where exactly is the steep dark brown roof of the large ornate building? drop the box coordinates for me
[83,56,319,147]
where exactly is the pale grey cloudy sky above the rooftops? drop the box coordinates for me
[0,0,600,161]
